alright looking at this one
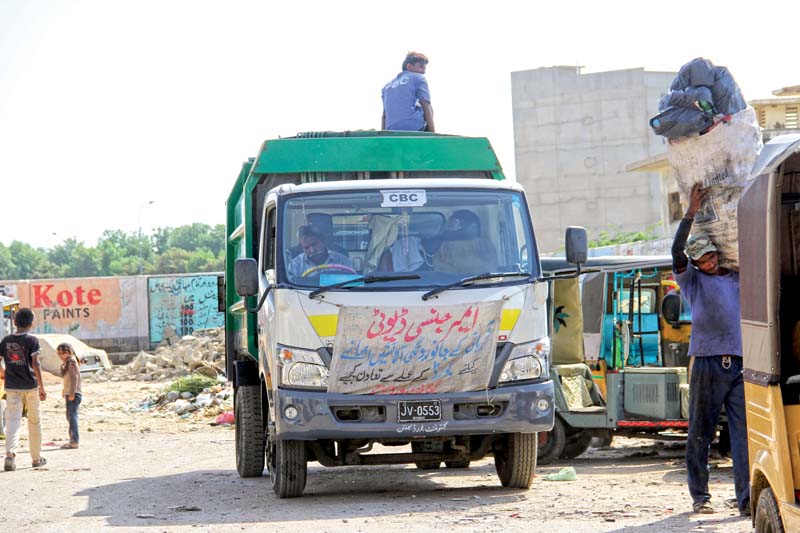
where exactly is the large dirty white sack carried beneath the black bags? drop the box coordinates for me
[667,107,763,270]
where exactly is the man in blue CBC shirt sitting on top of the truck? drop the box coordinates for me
[381,52,436,132]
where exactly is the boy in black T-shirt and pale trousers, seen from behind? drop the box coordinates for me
[0,307,47,471]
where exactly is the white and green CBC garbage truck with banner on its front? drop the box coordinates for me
[222,131,587,498]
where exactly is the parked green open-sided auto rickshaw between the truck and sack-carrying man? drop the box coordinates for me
[538,256,691,464]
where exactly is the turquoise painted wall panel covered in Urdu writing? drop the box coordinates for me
[147,275,225,343]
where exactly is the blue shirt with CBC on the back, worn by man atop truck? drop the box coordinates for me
[381,70,431,131]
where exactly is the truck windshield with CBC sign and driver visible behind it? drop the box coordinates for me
[278,188,539,290]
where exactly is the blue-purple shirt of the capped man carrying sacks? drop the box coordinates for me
[675,265,742,357]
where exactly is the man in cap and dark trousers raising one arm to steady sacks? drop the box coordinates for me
[672,183,750,515]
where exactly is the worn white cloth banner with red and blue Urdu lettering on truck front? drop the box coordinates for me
[328,302,503,394]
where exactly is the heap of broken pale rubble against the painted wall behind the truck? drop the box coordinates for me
[94,328,225,381]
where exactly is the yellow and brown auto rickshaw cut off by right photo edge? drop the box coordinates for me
[738,135,800,532]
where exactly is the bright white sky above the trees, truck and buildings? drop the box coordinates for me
[0,0,800,248]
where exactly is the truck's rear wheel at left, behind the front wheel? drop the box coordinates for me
[233,386,265,477]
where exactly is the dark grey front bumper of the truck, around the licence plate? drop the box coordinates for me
[272,380,554,440]
